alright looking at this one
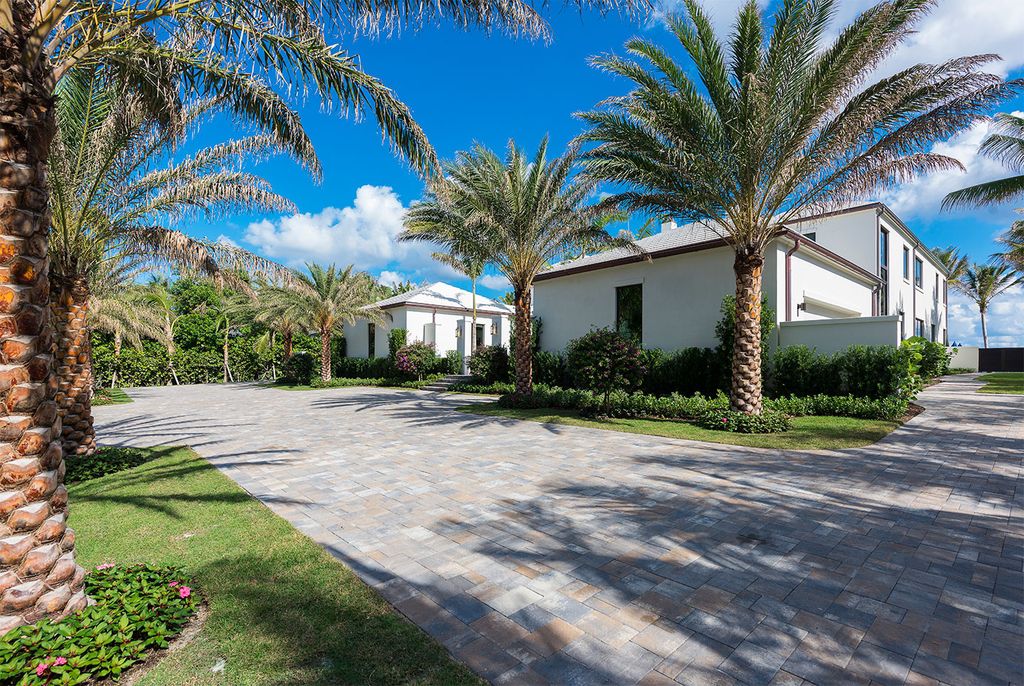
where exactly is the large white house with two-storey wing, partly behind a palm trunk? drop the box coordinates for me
[534,203,946,352]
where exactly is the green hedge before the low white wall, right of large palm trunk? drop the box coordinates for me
[769,345,921,400]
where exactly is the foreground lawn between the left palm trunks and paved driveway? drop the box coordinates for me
[70,448,481,686]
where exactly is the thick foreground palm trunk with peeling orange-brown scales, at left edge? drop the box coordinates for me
[0,26,86,635]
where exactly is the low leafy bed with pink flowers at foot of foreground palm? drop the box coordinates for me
[0,562,197,686]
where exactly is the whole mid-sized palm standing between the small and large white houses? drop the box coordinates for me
[398,138,635,396]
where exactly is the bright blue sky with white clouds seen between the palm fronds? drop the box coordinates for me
[192,0,1024,344]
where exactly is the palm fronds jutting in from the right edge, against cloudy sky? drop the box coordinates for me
[942,113,1024,210]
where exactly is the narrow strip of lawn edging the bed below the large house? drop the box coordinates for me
[459,402,898,449]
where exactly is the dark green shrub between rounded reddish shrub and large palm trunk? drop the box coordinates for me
[641,348,728,395]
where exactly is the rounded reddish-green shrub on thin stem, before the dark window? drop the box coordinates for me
[565,329,645,411]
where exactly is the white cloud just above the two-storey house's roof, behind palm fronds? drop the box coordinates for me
[880,112,1024,216]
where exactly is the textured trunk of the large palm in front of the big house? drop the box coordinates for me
[729,252,764,415]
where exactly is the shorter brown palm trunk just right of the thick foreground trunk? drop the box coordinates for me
[51,281,96,455]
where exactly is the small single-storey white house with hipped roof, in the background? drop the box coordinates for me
[345,282,512,359]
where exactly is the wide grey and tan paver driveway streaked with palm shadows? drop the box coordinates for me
[96,378,1024,686]
